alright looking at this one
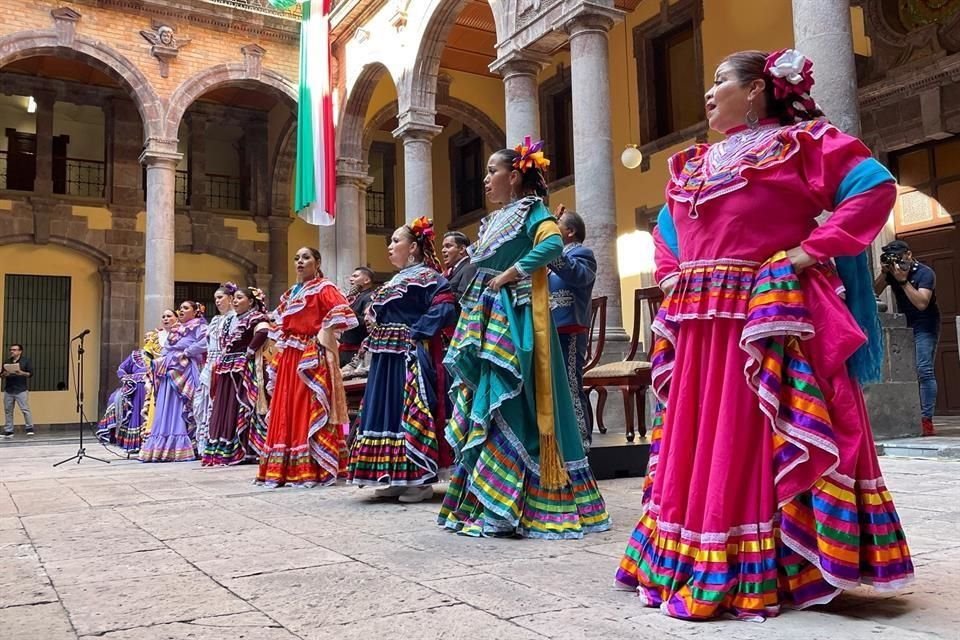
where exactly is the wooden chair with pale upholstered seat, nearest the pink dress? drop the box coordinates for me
[583,287,663,442]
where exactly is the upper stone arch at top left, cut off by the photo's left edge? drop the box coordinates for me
[0,30,163,140]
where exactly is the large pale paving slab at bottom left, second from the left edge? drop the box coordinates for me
[58,571,252,636]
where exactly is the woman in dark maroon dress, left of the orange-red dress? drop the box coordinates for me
[202,311,270,466]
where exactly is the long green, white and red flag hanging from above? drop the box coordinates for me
[270,0,337,225]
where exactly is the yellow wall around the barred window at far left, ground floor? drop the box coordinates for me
[0,244,103,424]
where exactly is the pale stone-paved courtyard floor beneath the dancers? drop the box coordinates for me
[0,434,960,640]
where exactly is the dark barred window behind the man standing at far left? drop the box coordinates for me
[3,274,70,391]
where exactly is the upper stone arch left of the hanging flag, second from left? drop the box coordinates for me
[163,62,298,140]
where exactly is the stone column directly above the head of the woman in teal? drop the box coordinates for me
[490,52,545,147]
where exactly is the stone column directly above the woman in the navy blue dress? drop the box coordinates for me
[393,117,443,222]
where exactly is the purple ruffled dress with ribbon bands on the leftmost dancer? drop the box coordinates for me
[97,349,153,452]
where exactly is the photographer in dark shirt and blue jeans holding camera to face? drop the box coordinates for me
[873,240,940,436]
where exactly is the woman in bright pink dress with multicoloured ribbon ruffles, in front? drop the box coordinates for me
[617,50,913,619]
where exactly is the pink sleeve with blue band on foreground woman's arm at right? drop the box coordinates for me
[800,126,897,260]
